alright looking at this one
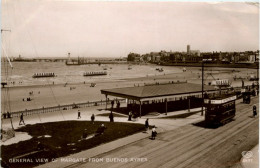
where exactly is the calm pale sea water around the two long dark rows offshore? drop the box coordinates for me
[1,62,185,86]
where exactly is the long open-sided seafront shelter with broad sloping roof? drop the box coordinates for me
[101,83,219,117]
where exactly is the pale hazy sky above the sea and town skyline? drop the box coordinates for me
[1,0,259,57]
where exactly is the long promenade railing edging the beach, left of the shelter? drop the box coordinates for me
[2,99,125,119]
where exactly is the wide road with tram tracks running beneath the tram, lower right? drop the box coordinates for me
[64,98,259,168]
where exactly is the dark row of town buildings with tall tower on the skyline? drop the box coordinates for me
[127,45,259,64]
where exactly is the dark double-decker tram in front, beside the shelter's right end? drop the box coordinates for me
[204,94,236,127]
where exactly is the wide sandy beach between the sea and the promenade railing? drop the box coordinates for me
[1,67,256,112]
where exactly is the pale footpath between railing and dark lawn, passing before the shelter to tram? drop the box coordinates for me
[2,105,203,131]
